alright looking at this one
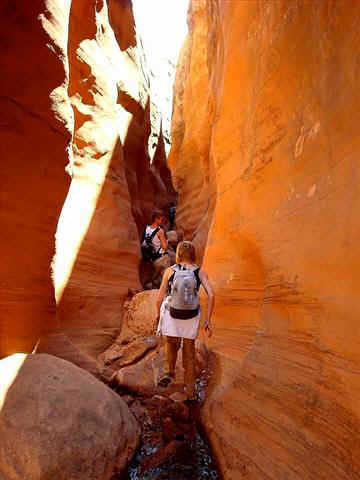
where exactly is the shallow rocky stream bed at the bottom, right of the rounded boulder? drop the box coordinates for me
[113,375,221,480]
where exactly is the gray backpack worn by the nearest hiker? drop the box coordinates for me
[169,264,200,320]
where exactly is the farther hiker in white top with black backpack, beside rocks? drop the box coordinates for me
[141,212,175,288]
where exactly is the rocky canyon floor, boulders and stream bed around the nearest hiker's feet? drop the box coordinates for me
[98,290,219,480]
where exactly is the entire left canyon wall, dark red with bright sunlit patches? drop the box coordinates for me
[0,0,175,360]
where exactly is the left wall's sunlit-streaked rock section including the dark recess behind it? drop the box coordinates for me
[54,0,176,356]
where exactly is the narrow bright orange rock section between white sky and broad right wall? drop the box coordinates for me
[169,0,216,257]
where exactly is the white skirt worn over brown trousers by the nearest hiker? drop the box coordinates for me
[156,297,201,339]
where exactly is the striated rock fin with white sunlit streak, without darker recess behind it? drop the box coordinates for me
[54,0,142,355]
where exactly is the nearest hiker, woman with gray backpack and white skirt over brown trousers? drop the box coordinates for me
[156,241,215,402]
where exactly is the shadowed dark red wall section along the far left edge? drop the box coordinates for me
[0,0,72,357]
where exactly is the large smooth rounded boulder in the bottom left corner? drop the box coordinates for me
[0,354,138,480]
